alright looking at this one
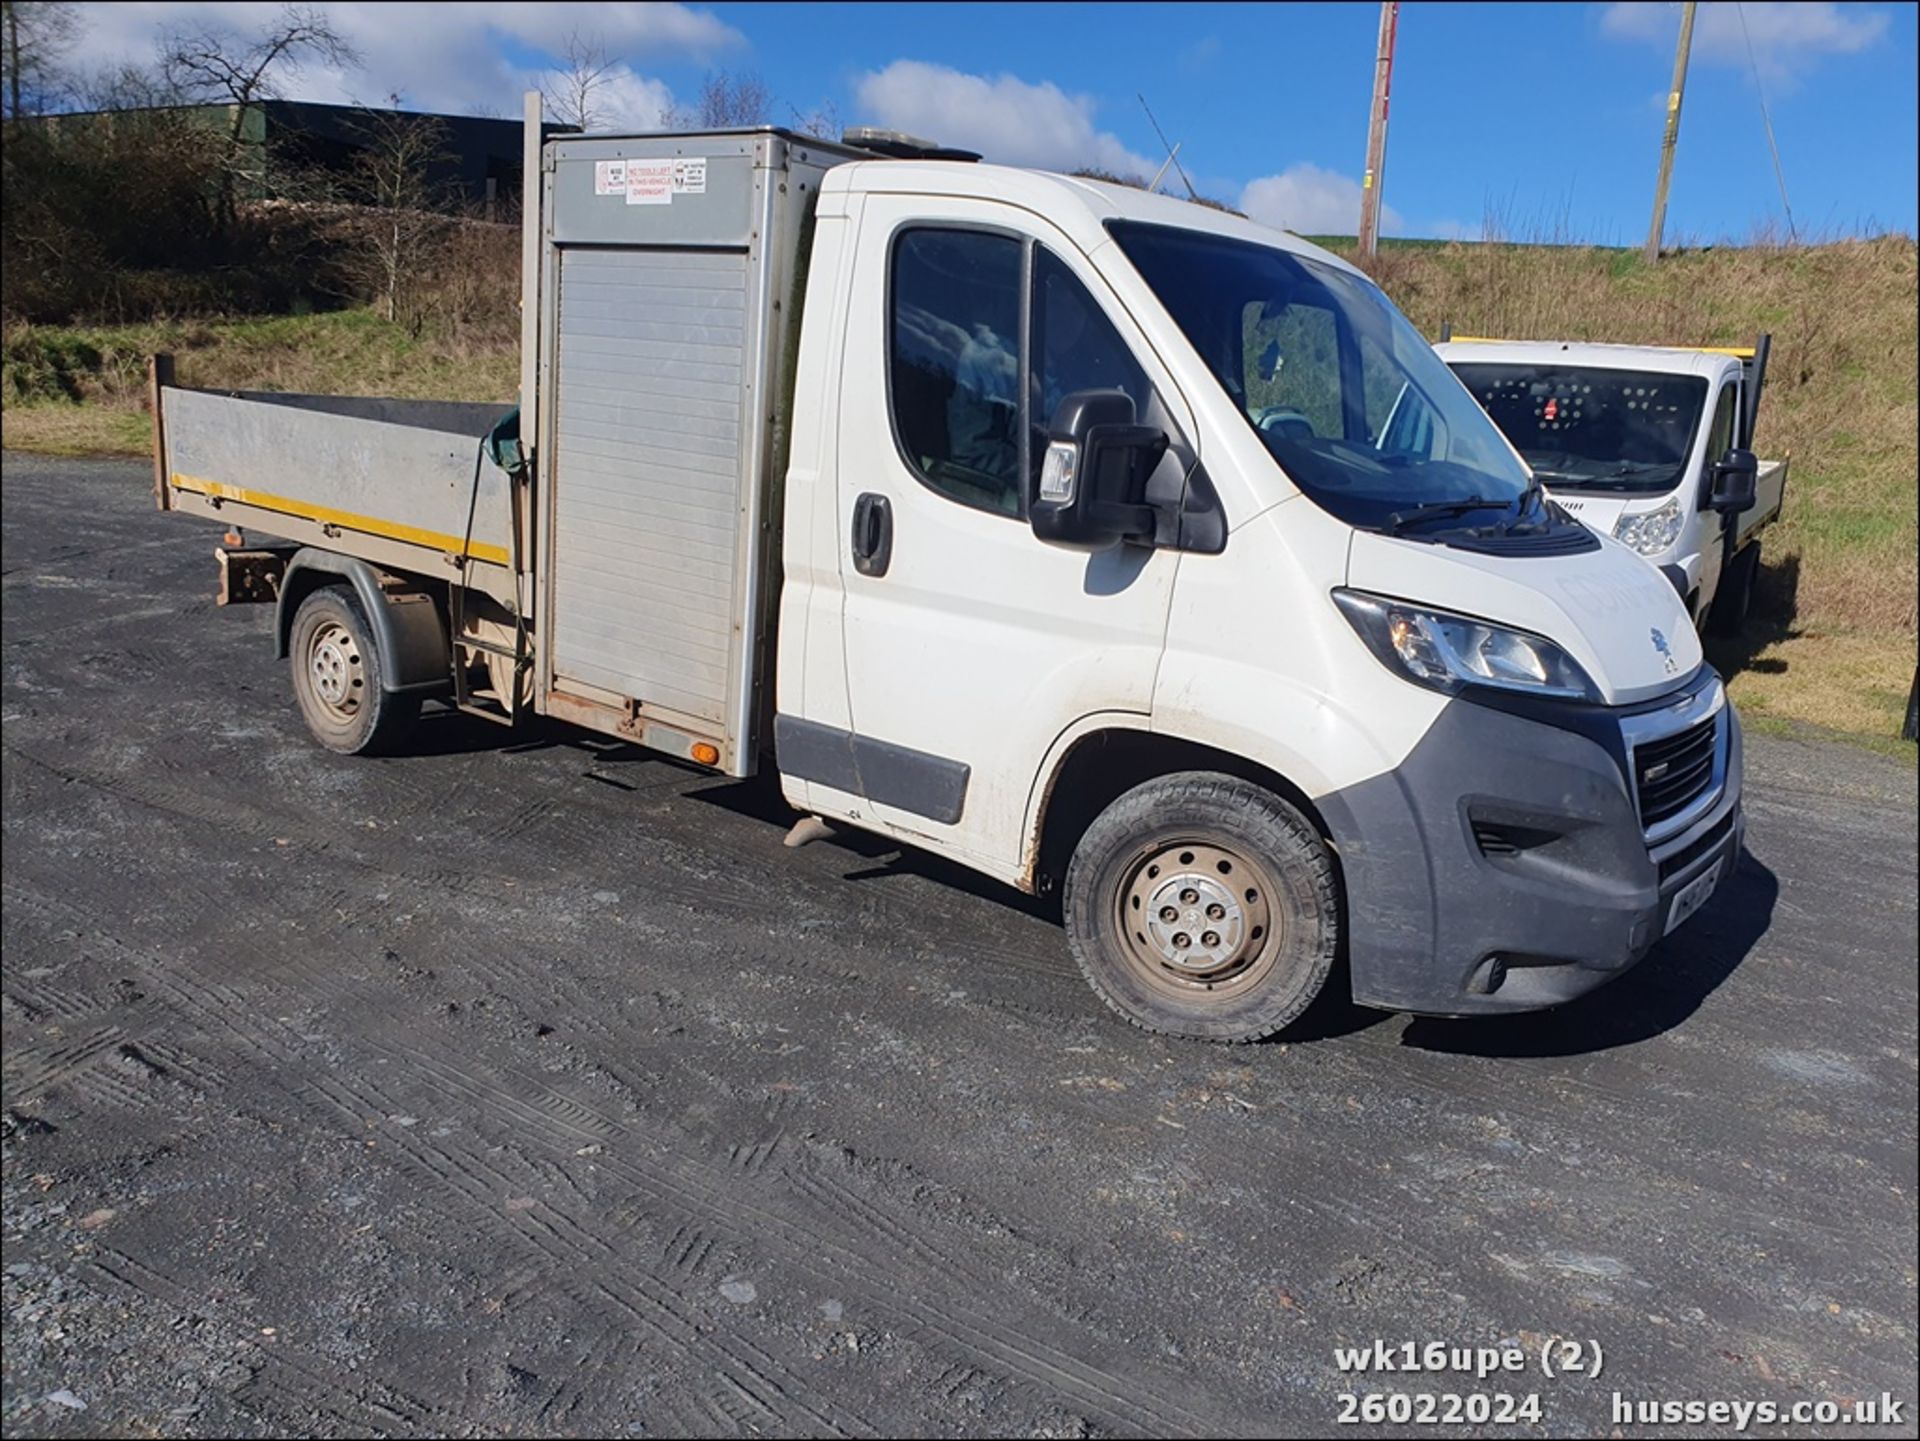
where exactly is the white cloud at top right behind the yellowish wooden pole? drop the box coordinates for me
[1599,0,1887,85]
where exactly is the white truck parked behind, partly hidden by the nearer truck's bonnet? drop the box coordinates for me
[1436,336,1788,635]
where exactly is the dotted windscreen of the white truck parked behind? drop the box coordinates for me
[1453,361,1707,493]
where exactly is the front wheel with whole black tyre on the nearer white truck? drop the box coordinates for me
[1062,771,1340,1042]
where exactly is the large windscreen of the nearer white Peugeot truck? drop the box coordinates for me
[1110,223,1538,533]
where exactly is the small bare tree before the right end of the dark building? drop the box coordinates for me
[346,98,451,334]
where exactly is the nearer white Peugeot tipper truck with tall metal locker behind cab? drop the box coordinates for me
[156,107,1743,1042]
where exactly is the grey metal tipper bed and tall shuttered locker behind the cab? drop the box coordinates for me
[156,130,858,775]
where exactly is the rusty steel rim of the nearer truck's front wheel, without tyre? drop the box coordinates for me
[1116,839,1286,1002]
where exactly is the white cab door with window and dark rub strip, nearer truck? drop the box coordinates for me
[817,194,1192,879]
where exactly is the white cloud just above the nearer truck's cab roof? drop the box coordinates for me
[854,59,1158,178]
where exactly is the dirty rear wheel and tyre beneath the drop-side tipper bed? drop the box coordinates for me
[286,585,420,756]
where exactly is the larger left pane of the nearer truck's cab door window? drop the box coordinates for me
[887,228,1025,516]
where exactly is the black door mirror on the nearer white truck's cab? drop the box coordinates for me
[1027,390,1167,547]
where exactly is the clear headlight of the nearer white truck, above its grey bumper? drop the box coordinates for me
[1332,589,1599,700]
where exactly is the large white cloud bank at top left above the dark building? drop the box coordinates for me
[67,0,745,115]
